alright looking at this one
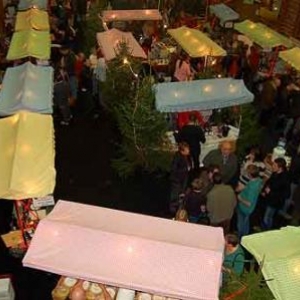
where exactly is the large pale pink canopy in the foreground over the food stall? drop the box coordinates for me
[23,200,224,300]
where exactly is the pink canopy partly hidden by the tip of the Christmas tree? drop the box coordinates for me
[97,28,147,60]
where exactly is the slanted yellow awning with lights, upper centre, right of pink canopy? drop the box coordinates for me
[168,26,226,57]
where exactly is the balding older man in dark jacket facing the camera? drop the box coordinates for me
[203,141,238,184]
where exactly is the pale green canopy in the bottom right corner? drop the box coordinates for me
[242,227,300,300]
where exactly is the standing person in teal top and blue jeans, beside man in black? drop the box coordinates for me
[237,165,263,239]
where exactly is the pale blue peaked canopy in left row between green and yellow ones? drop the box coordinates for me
[0,62,53,116]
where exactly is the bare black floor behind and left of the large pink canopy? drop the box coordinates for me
[0,108,168,300]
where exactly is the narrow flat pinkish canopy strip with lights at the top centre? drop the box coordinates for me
[102,9,162,22]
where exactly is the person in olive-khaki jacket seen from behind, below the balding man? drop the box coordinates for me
[206,173,236,234]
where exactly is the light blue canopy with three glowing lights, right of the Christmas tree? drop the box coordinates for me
[154,78,254,112]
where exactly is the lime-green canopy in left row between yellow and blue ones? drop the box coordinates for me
[7,29,50,60]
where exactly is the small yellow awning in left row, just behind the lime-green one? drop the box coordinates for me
[15,8,50,31]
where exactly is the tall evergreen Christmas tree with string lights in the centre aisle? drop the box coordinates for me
[103,41,171,177]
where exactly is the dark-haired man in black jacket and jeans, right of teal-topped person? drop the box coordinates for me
[262,158,290,229]
